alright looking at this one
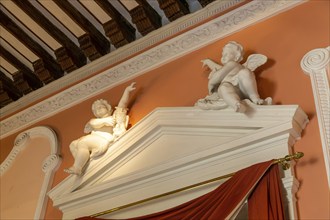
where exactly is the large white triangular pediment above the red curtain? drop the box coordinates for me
[49,105,308,218]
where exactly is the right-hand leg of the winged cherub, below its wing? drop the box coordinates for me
[238,69,264,105]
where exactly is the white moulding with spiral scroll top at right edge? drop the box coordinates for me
[301,46,330,186]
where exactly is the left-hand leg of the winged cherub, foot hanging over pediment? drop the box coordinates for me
[218,82,246,112]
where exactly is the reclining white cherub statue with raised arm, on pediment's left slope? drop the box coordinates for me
[64,82,135,175]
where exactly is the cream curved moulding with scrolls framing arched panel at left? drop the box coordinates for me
[0,126,61,219]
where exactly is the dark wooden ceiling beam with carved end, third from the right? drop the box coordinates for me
[129,0,162,36]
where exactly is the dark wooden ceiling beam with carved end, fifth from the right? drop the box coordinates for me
[54,0,110,60]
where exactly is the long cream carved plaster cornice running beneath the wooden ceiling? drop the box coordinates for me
[0,0,305,138]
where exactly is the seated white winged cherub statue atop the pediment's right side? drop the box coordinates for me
[195,41,272,112]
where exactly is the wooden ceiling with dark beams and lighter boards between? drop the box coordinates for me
[0,0,218,108]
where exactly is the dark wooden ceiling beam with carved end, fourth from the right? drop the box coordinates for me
[95,0,135,48]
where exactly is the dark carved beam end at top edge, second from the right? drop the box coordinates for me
[157,0,190,21]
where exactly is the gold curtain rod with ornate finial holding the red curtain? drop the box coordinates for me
[90,152,304,217]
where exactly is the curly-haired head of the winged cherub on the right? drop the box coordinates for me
[221,41,244,64]
